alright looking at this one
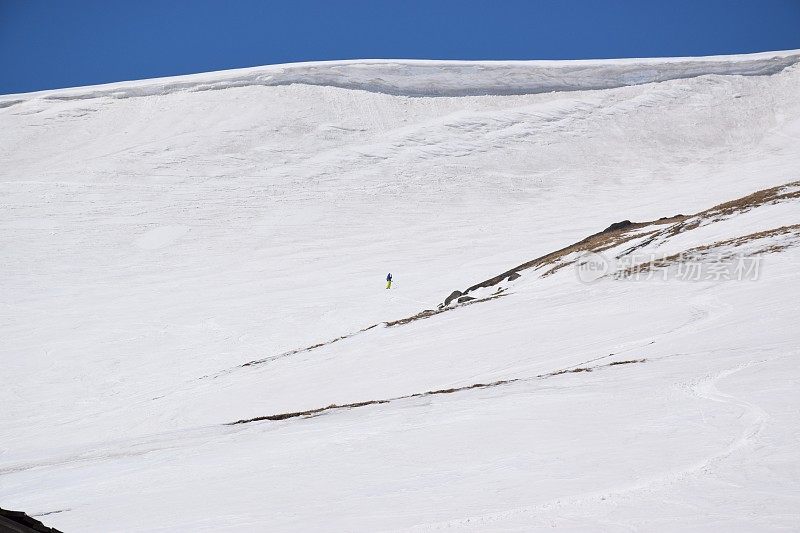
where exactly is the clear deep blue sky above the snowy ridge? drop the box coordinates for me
[0,0,800,94]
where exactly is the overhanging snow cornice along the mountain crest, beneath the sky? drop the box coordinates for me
[0,50,800,102]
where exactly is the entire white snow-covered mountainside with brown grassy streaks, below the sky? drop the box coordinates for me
[0,52,800,532]
